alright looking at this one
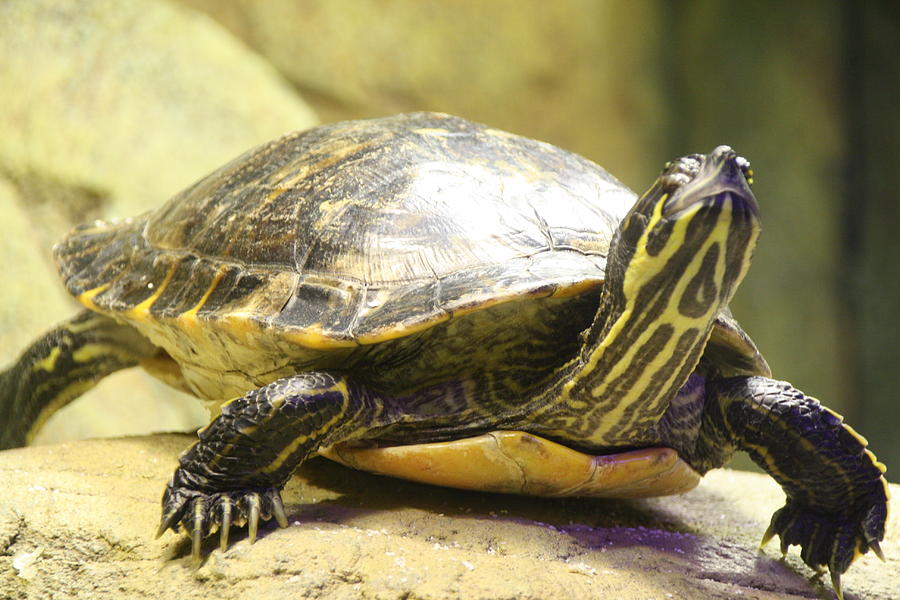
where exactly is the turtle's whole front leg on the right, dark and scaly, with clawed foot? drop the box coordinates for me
[698,377,889,597]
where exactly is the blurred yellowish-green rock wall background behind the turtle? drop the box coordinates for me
[0,0,900,468]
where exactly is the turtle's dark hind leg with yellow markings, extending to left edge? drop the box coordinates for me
[0,310,158,449]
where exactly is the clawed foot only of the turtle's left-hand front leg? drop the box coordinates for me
[156,483,288,561]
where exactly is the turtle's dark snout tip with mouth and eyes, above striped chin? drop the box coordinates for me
[662,146,759,219]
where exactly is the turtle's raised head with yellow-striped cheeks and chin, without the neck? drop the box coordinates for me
[608,146,760,319]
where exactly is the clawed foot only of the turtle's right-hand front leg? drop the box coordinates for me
[760,500,887,600]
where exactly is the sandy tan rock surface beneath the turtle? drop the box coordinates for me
[0,434,900,600]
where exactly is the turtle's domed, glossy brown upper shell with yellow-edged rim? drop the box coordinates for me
[56,113,635,394]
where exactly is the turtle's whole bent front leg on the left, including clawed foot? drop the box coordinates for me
[157,372,381,559]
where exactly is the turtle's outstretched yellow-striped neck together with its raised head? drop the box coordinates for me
[533,153,759,450]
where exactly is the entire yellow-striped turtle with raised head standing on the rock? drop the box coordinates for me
[0,112,888,594]
